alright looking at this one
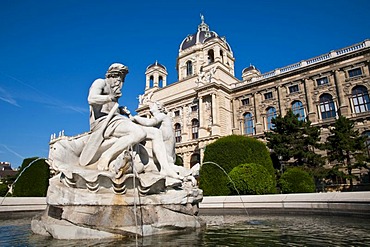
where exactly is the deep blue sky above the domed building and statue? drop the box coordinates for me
[0,0,370,168]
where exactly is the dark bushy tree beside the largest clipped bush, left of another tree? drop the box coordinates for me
[265,110,324,171]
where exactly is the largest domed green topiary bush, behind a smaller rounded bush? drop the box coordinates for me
[199,135,274,196]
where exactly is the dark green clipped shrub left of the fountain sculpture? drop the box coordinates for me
[13,158,50,197]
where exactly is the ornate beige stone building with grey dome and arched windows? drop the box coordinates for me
[136,17,370,171]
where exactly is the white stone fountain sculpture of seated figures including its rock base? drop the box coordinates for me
[31,63,204,239]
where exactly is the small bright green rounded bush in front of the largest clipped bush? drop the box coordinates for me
[227,163,276,195]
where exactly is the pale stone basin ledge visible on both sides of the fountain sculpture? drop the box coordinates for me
[0,191,370,215]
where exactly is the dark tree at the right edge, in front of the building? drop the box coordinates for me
[325,116,367,188]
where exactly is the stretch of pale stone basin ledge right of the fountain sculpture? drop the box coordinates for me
[199,191,370,215]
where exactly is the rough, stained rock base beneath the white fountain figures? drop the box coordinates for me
[31,176,205,239]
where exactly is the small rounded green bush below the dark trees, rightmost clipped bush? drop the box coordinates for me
[279,167,315,194]
